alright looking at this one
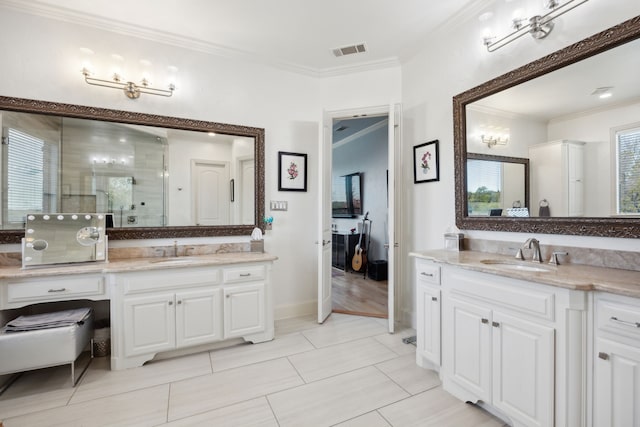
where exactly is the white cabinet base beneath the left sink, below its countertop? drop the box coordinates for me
[111,263,274,369]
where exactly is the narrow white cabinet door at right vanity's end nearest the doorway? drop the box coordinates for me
[417,282,440,365]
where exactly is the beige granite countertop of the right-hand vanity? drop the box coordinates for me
[409,250,640,298]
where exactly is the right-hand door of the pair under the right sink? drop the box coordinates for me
[492,311,554,427]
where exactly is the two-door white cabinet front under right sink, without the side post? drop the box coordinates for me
[442,272,555,427]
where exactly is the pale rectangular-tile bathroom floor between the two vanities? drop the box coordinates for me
[0,314,504,427]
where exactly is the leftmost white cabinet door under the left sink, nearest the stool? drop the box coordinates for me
[124,293,176,356]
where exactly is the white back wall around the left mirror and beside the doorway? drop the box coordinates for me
[0,9,400,317]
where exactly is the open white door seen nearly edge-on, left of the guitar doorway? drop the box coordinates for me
[317,113,333,323]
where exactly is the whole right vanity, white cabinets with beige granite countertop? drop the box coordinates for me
[411,251,640,426]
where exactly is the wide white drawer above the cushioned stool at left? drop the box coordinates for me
[6,275,105,303]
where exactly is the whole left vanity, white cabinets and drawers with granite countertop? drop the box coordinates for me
[0,252,276,370]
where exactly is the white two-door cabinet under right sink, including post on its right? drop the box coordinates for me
[441,266,587,427]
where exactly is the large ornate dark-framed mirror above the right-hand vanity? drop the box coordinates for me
[453,17,640,238]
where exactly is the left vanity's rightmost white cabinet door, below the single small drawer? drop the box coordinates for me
[224,283,265,339]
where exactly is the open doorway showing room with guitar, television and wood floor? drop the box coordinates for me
[331,114,389,318]
